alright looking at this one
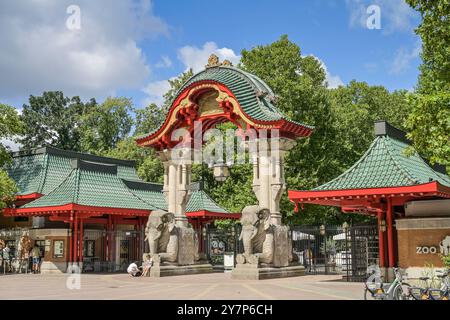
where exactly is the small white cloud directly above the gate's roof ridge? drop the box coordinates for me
[178,41,241,73]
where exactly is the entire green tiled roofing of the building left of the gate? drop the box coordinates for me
[7,147,232,213]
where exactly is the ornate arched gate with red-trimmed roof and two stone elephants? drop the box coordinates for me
[136,55,314,279]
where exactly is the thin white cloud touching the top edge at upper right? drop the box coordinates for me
[345,0,418,34]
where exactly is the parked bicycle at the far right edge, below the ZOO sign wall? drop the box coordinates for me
[408,270,450,300]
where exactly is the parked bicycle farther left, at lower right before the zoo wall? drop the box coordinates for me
[364,268,411,300]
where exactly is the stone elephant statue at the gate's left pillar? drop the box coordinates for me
[145,210,178,264]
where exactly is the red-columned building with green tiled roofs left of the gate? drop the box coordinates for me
[0,147,240,272]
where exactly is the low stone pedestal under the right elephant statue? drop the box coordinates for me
[231,264,305,280]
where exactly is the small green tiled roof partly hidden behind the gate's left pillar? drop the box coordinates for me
[124,181,229,213]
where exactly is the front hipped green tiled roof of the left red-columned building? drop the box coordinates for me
[22,161,156,210]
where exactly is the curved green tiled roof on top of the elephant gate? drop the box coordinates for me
[138,66,314,139]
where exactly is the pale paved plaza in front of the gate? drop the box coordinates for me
[0,273,363,300]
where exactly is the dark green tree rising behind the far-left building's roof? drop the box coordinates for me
[20,91,96,151]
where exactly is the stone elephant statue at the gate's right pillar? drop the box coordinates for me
[236,206,274,264]
